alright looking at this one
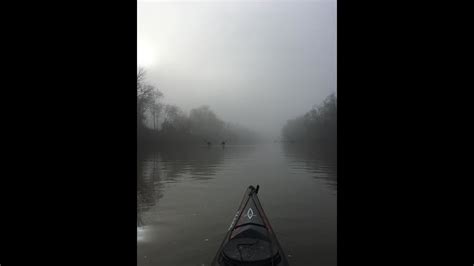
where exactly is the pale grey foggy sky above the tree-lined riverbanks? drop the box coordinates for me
[137,0,337,137]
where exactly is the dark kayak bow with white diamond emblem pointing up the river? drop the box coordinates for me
[211,186,289,266]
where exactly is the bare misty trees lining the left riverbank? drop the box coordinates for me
[137,69,260,149]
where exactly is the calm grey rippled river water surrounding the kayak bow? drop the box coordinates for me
[137,143,337,266]
